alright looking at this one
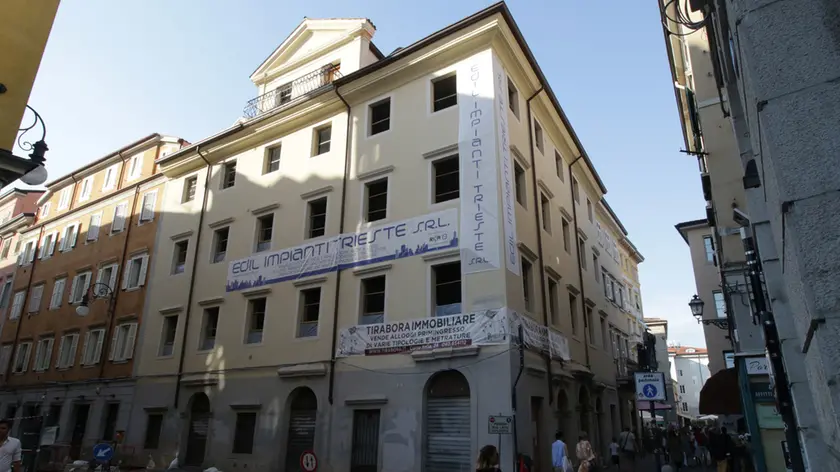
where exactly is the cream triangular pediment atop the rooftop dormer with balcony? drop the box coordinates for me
[251,18,375,84]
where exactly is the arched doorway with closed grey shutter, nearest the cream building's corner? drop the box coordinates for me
[423,370,474,472]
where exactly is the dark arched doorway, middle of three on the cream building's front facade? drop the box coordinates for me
[286,387,318,472]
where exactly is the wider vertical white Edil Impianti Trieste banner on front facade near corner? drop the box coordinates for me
[456,49,502,275]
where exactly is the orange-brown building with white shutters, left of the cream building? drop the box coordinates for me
[0,134,183,470]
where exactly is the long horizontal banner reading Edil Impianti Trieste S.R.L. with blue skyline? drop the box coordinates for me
[226,208,458,292]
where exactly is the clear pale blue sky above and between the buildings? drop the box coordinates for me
[19,0,704,346]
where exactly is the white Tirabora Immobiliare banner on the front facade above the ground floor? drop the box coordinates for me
[336,309,510,357]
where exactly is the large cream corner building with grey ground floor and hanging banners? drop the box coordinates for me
[127,4,642,472]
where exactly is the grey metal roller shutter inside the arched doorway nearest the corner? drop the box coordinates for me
[425,397,474,472]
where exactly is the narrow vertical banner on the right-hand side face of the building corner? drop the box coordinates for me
[493,54,519,275]
